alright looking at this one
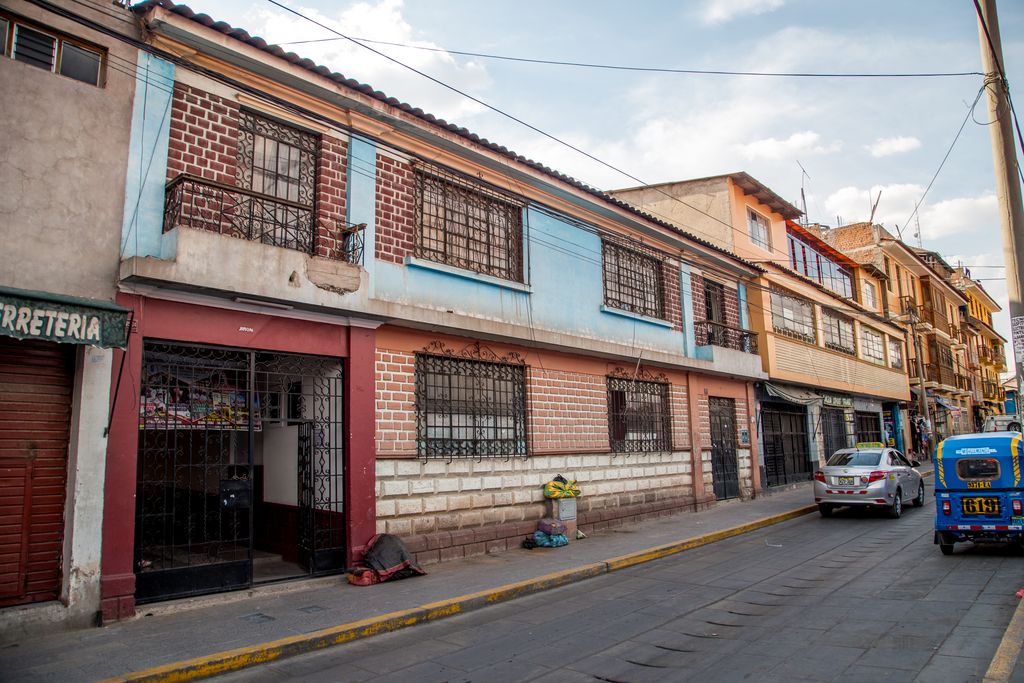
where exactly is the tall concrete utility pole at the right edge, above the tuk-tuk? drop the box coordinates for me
[975,0,1024,411]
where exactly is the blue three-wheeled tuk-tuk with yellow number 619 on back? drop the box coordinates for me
[935,432,1024,555]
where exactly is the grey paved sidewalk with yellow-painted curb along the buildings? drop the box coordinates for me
[0,464,966,681]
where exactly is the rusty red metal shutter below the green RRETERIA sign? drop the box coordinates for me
[0,337,75,606]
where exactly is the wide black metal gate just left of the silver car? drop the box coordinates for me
[761,403,812,486]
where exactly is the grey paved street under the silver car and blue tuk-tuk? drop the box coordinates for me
[220,486,1024,683]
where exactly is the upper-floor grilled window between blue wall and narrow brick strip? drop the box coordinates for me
[601,241,665,318]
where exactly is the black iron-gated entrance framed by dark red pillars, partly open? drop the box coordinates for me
[134,343,345,603]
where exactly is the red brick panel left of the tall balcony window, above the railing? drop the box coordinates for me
[167,83,239,185]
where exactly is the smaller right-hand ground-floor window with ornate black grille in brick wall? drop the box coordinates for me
[608,377,669,453]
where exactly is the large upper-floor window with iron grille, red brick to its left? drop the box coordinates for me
[415,169,525,283]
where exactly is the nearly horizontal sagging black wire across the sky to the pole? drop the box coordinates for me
[278,34,984,78]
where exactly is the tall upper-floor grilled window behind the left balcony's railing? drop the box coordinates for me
[234,110,319,253]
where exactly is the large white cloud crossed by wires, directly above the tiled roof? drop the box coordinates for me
[247,0,492,123]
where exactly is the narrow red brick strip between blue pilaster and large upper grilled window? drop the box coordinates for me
[376,155,416,263]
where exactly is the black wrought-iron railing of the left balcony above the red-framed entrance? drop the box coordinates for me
[164,173,362,263]
